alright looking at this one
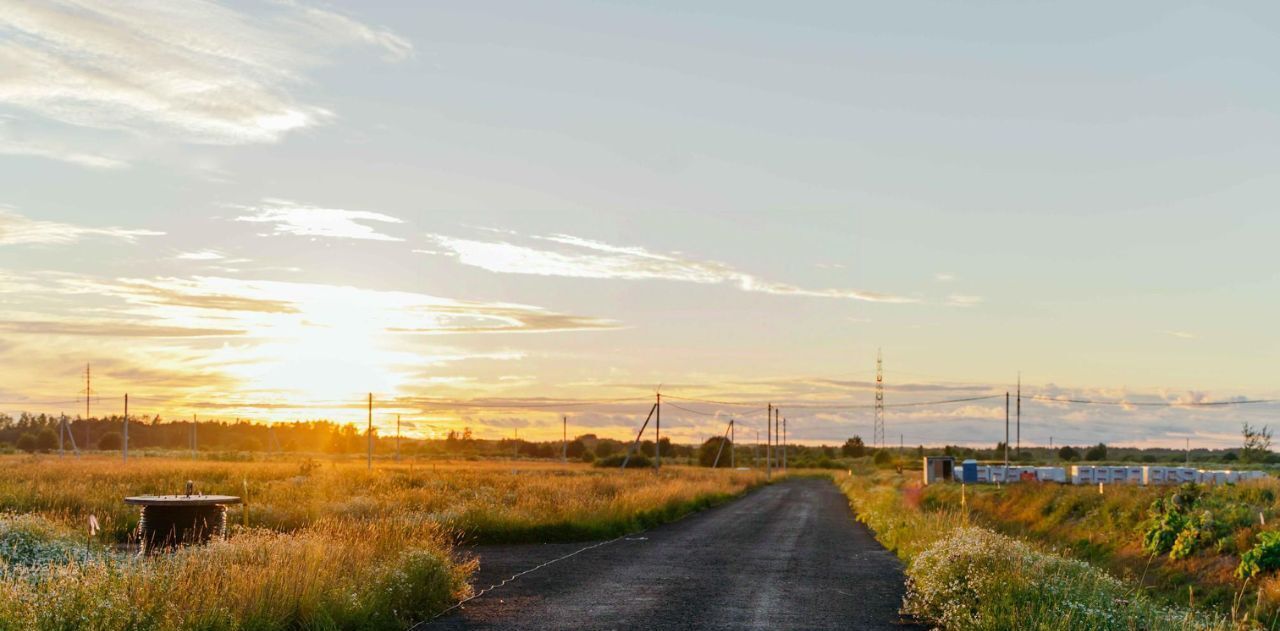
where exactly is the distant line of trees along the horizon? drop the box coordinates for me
[0,413,1259,468]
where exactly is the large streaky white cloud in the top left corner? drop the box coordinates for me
[0,0,412,145]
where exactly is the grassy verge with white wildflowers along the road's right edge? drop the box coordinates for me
[837,472,1247,631]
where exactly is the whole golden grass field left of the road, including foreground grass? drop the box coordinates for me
[0,456,763,630]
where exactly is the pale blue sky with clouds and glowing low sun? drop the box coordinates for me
[0,0,1280,447]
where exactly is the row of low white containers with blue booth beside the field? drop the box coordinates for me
[924,457,1267,485]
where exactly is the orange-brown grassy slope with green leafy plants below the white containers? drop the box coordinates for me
[919,479,1280,628]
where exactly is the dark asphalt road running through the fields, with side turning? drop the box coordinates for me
[422,480,916,630]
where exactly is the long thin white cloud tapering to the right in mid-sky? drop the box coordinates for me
[430,234,916,302]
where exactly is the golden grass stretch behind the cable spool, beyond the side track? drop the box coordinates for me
[0,456,763,543]
